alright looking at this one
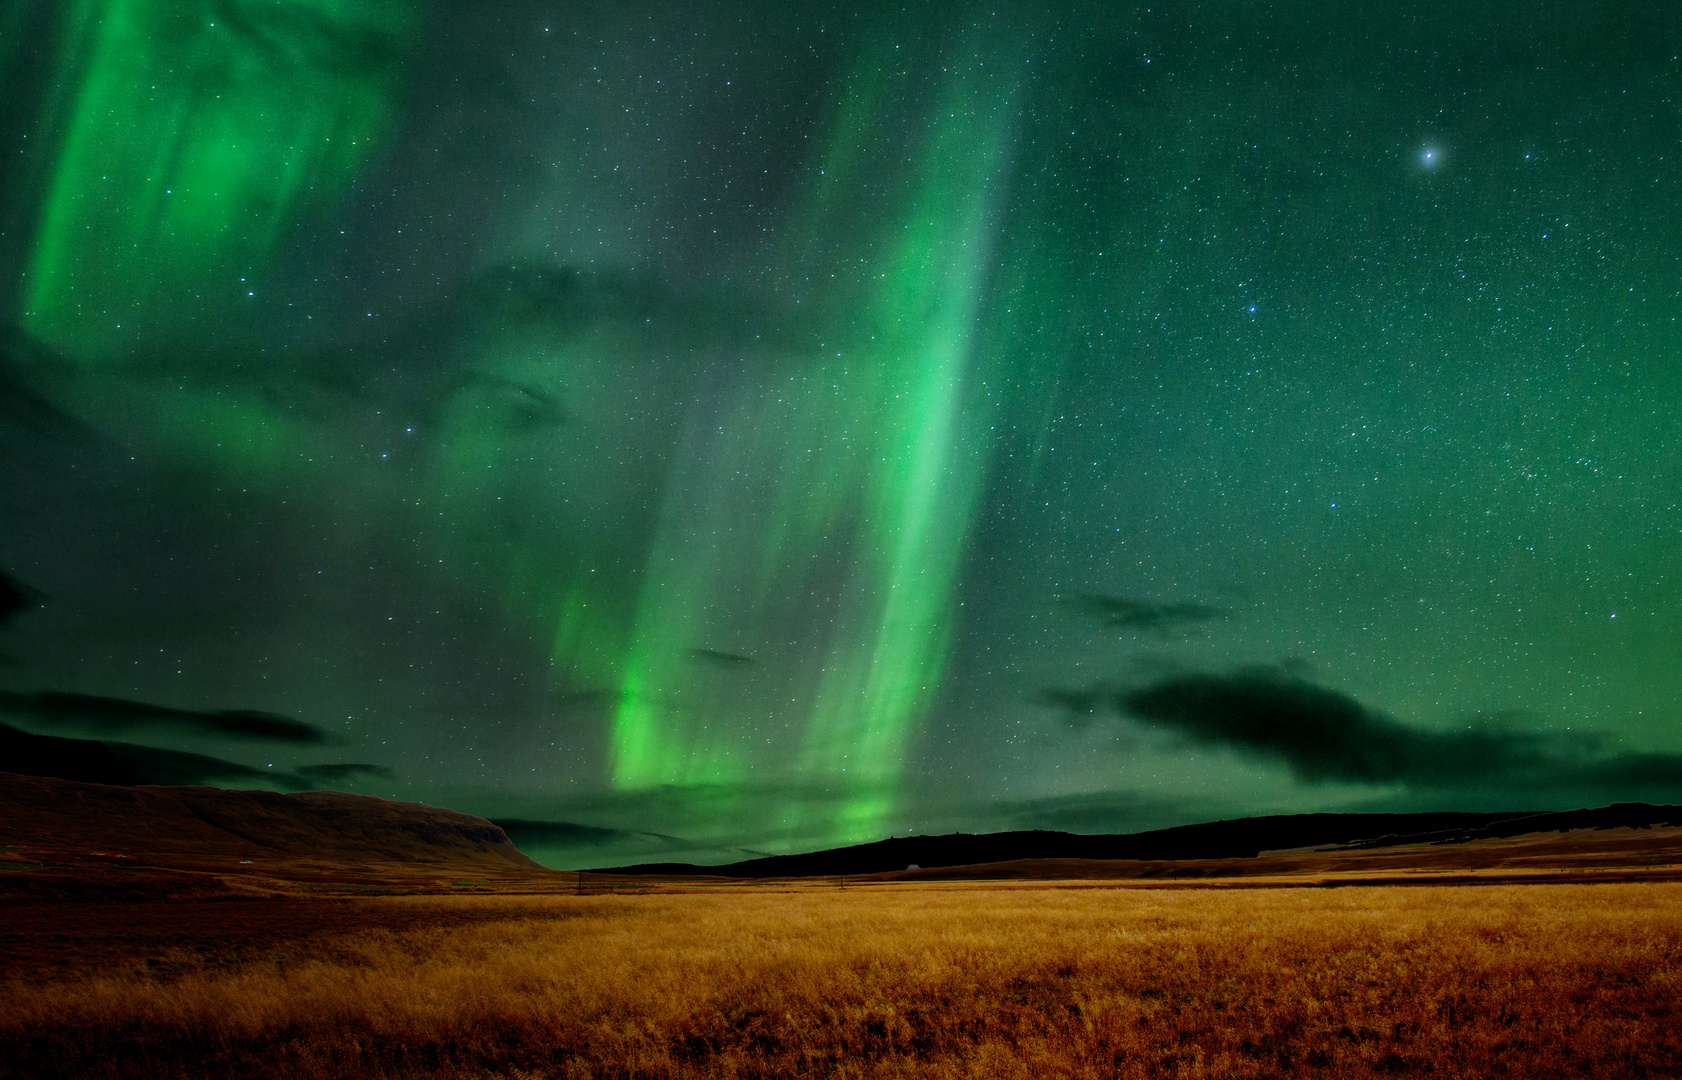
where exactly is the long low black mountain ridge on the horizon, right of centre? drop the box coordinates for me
[590,802,1682,878]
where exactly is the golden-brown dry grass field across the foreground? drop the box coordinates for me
[0,883,1682,1080]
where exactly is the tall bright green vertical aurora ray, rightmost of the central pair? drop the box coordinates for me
[787,56,1009,839]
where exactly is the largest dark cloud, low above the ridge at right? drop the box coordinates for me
[1048,668,1682,792]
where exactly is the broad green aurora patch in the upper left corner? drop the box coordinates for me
[22,0,412,362]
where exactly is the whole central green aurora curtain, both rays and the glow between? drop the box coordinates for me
[612,35,1014,843]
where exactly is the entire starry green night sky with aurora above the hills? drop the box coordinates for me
[0,0,1682,866]
